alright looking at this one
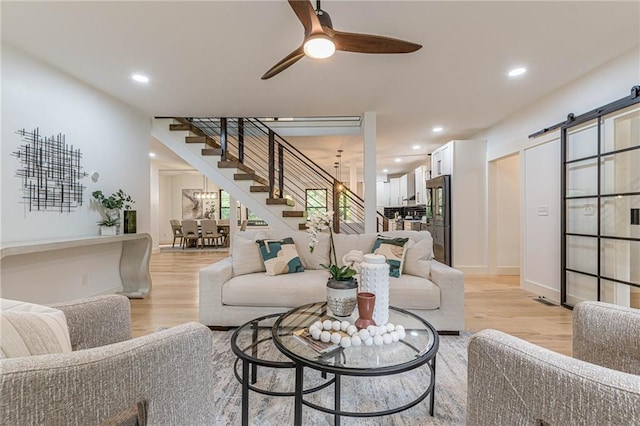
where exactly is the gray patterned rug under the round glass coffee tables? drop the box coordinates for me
[213,330,470,426]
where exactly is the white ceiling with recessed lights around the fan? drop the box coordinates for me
[2,0,640,177]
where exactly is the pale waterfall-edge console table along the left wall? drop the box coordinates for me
[0,234,151,299]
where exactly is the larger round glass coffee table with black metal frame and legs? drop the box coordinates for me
[271,302,439,425]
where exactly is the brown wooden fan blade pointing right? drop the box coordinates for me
[325,28,422,53]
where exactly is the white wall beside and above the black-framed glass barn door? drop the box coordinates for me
[475,48,640,300]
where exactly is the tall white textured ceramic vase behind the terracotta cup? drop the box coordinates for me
[360,254,389,325]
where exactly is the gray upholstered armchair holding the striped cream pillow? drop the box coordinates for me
[0,295,214,425]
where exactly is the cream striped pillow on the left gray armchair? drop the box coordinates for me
[0,299,71,358]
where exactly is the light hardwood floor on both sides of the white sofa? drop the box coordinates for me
[131,250,572,355]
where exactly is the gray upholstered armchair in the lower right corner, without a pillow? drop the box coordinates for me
[467,302,640,425]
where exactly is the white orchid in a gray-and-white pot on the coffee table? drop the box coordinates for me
[306,211,358,317]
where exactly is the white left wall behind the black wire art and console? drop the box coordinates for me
[0,43,151,302]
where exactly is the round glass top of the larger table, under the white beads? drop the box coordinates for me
[272,302,438,375]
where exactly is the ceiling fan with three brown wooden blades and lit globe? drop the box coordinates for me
[262,0,422,80]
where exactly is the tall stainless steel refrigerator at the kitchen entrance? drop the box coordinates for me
[425,175,452,266]
